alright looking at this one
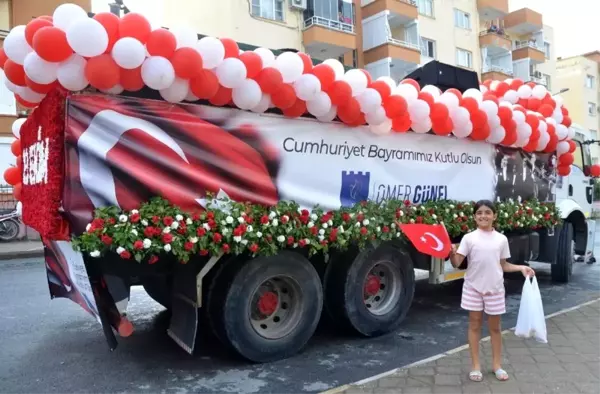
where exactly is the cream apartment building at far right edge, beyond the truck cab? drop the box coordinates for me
[555,51,600,164]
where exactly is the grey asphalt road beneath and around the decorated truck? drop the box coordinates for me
[0,234,600,394]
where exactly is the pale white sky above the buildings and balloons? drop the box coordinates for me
[92,0,600,57]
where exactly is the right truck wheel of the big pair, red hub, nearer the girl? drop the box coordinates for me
[325,242,415,337]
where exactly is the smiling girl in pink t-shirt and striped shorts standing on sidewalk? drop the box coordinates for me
[450,200,535,382]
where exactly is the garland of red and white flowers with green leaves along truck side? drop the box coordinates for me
[73,198,560,264]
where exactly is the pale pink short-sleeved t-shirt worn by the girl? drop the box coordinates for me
[456,229,510,294]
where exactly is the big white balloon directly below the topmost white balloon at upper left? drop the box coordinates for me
[67,18,108,57]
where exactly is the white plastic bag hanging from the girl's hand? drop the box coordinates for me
[515,276,548,343]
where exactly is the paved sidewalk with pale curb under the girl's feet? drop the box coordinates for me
[323,300,600,394]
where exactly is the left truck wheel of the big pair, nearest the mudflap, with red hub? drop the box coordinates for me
[207,251,323,363]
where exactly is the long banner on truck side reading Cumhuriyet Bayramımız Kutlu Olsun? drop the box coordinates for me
[63,95,548,232]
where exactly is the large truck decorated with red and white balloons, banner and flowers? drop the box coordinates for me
[0,4,600,362]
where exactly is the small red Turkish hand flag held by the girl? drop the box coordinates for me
[400,224,452,259]
